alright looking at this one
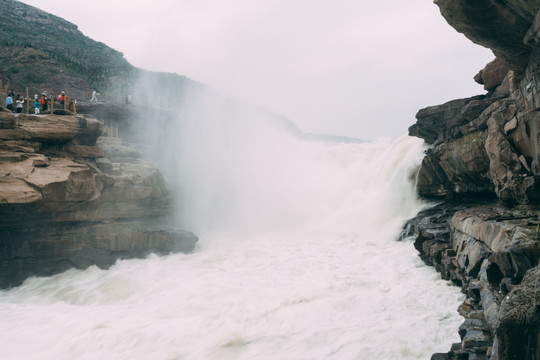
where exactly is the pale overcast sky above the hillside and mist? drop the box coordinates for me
[23,0,494,139]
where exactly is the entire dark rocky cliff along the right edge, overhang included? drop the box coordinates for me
[409,0,540,360]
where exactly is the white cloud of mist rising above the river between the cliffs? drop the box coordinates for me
[133,73,428,235]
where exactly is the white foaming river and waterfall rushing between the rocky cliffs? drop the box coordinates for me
[0,133,462,360]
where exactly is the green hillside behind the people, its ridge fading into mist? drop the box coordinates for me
[0,0,312,144]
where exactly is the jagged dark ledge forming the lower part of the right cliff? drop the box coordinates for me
[405,202,540,360]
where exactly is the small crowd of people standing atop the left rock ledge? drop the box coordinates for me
[2,91,85,115]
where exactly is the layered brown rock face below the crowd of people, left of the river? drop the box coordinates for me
[0,111,197,286]
